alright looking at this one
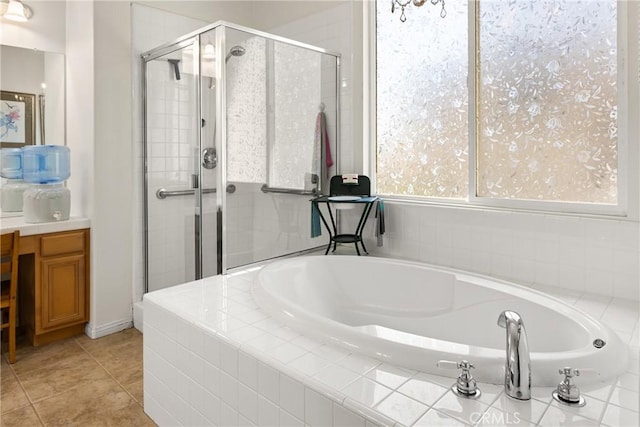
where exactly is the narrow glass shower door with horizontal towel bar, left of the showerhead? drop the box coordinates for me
[145,37,202,291]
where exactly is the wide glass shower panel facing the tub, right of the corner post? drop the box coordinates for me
[220,28,338,268]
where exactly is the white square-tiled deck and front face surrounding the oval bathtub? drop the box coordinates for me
[144,269,640,427]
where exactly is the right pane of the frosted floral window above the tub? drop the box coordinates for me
[476,0,618,204]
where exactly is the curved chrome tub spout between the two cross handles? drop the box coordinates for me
[498,310,531,400]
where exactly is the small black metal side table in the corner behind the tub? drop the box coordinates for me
[311,196,379,256]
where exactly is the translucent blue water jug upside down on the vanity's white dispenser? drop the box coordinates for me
[22,145,71,184]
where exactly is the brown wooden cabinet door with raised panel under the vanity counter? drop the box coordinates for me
[40,254,87,330]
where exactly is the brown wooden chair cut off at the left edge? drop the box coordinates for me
[0,231,20,363]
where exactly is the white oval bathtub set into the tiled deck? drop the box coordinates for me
[252,256,628,386]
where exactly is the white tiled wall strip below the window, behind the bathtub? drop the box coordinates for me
[365,202,640,301]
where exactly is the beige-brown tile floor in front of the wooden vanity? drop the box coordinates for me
[0,328,155,427]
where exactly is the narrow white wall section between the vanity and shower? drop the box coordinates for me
[82,1,133,336]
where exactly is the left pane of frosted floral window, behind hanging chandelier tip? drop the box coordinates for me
[376,0,469,199]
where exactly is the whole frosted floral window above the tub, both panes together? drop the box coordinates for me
[376,0,619,205]
